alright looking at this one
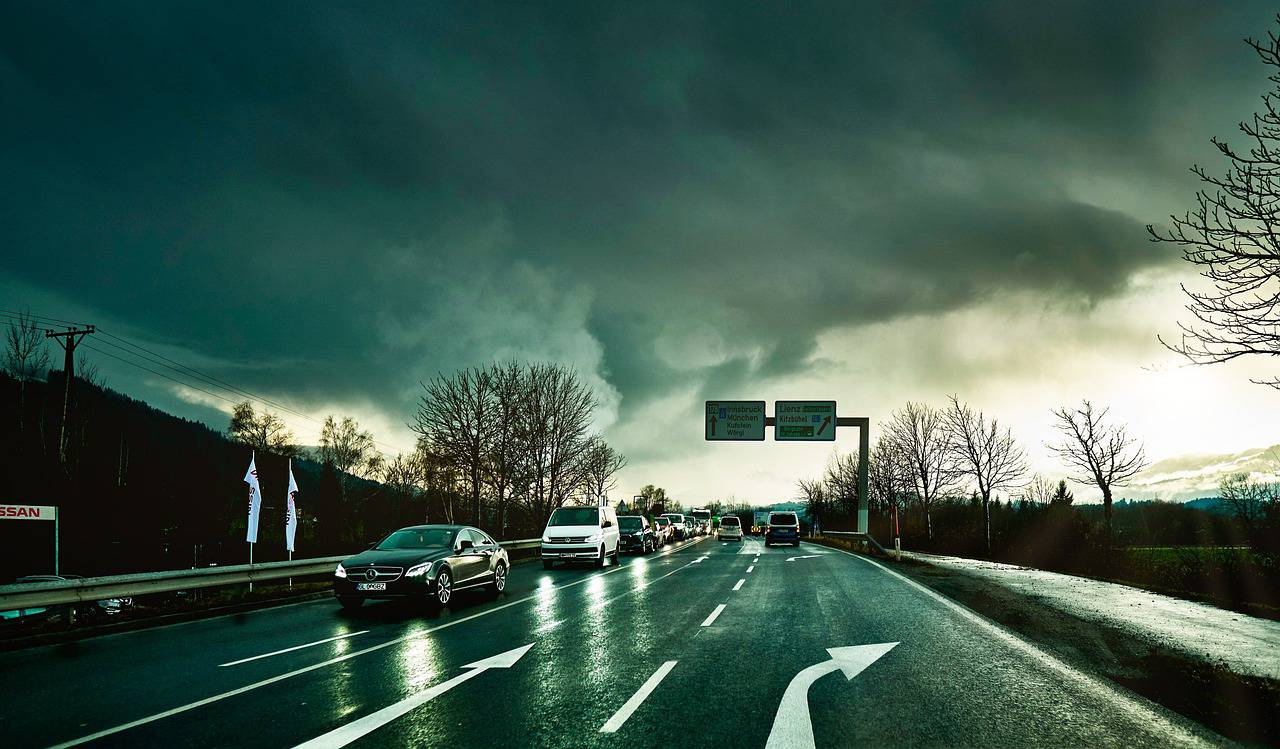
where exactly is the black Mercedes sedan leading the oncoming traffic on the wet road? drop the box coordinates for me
[333,525,511,608]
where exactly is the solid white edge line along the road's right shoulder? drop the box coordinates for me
[814,549,1212,746]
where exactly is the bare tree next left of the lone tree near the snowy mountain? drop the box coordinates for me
[946,396,1027,557]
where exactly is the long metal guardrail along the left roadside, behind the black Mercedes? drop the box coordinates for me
[0,538,541,611]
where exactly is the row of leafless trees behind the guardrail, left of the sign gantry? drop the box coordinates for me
[228,361,627,538]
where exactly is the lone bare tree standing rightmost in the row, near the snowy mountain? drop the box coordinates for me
[1048,401,1147,560]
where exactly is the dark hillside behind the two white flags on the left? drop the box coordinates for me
[0,373,394,580]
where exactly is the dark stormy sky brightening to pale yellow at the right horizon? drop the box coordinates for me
[0,1,1280,503]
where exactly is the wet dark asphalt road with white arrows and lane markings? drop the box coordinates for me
[0,538,1224,748]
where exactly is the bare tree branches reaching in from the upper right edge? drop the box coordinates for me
[1147,18,1280,388]
